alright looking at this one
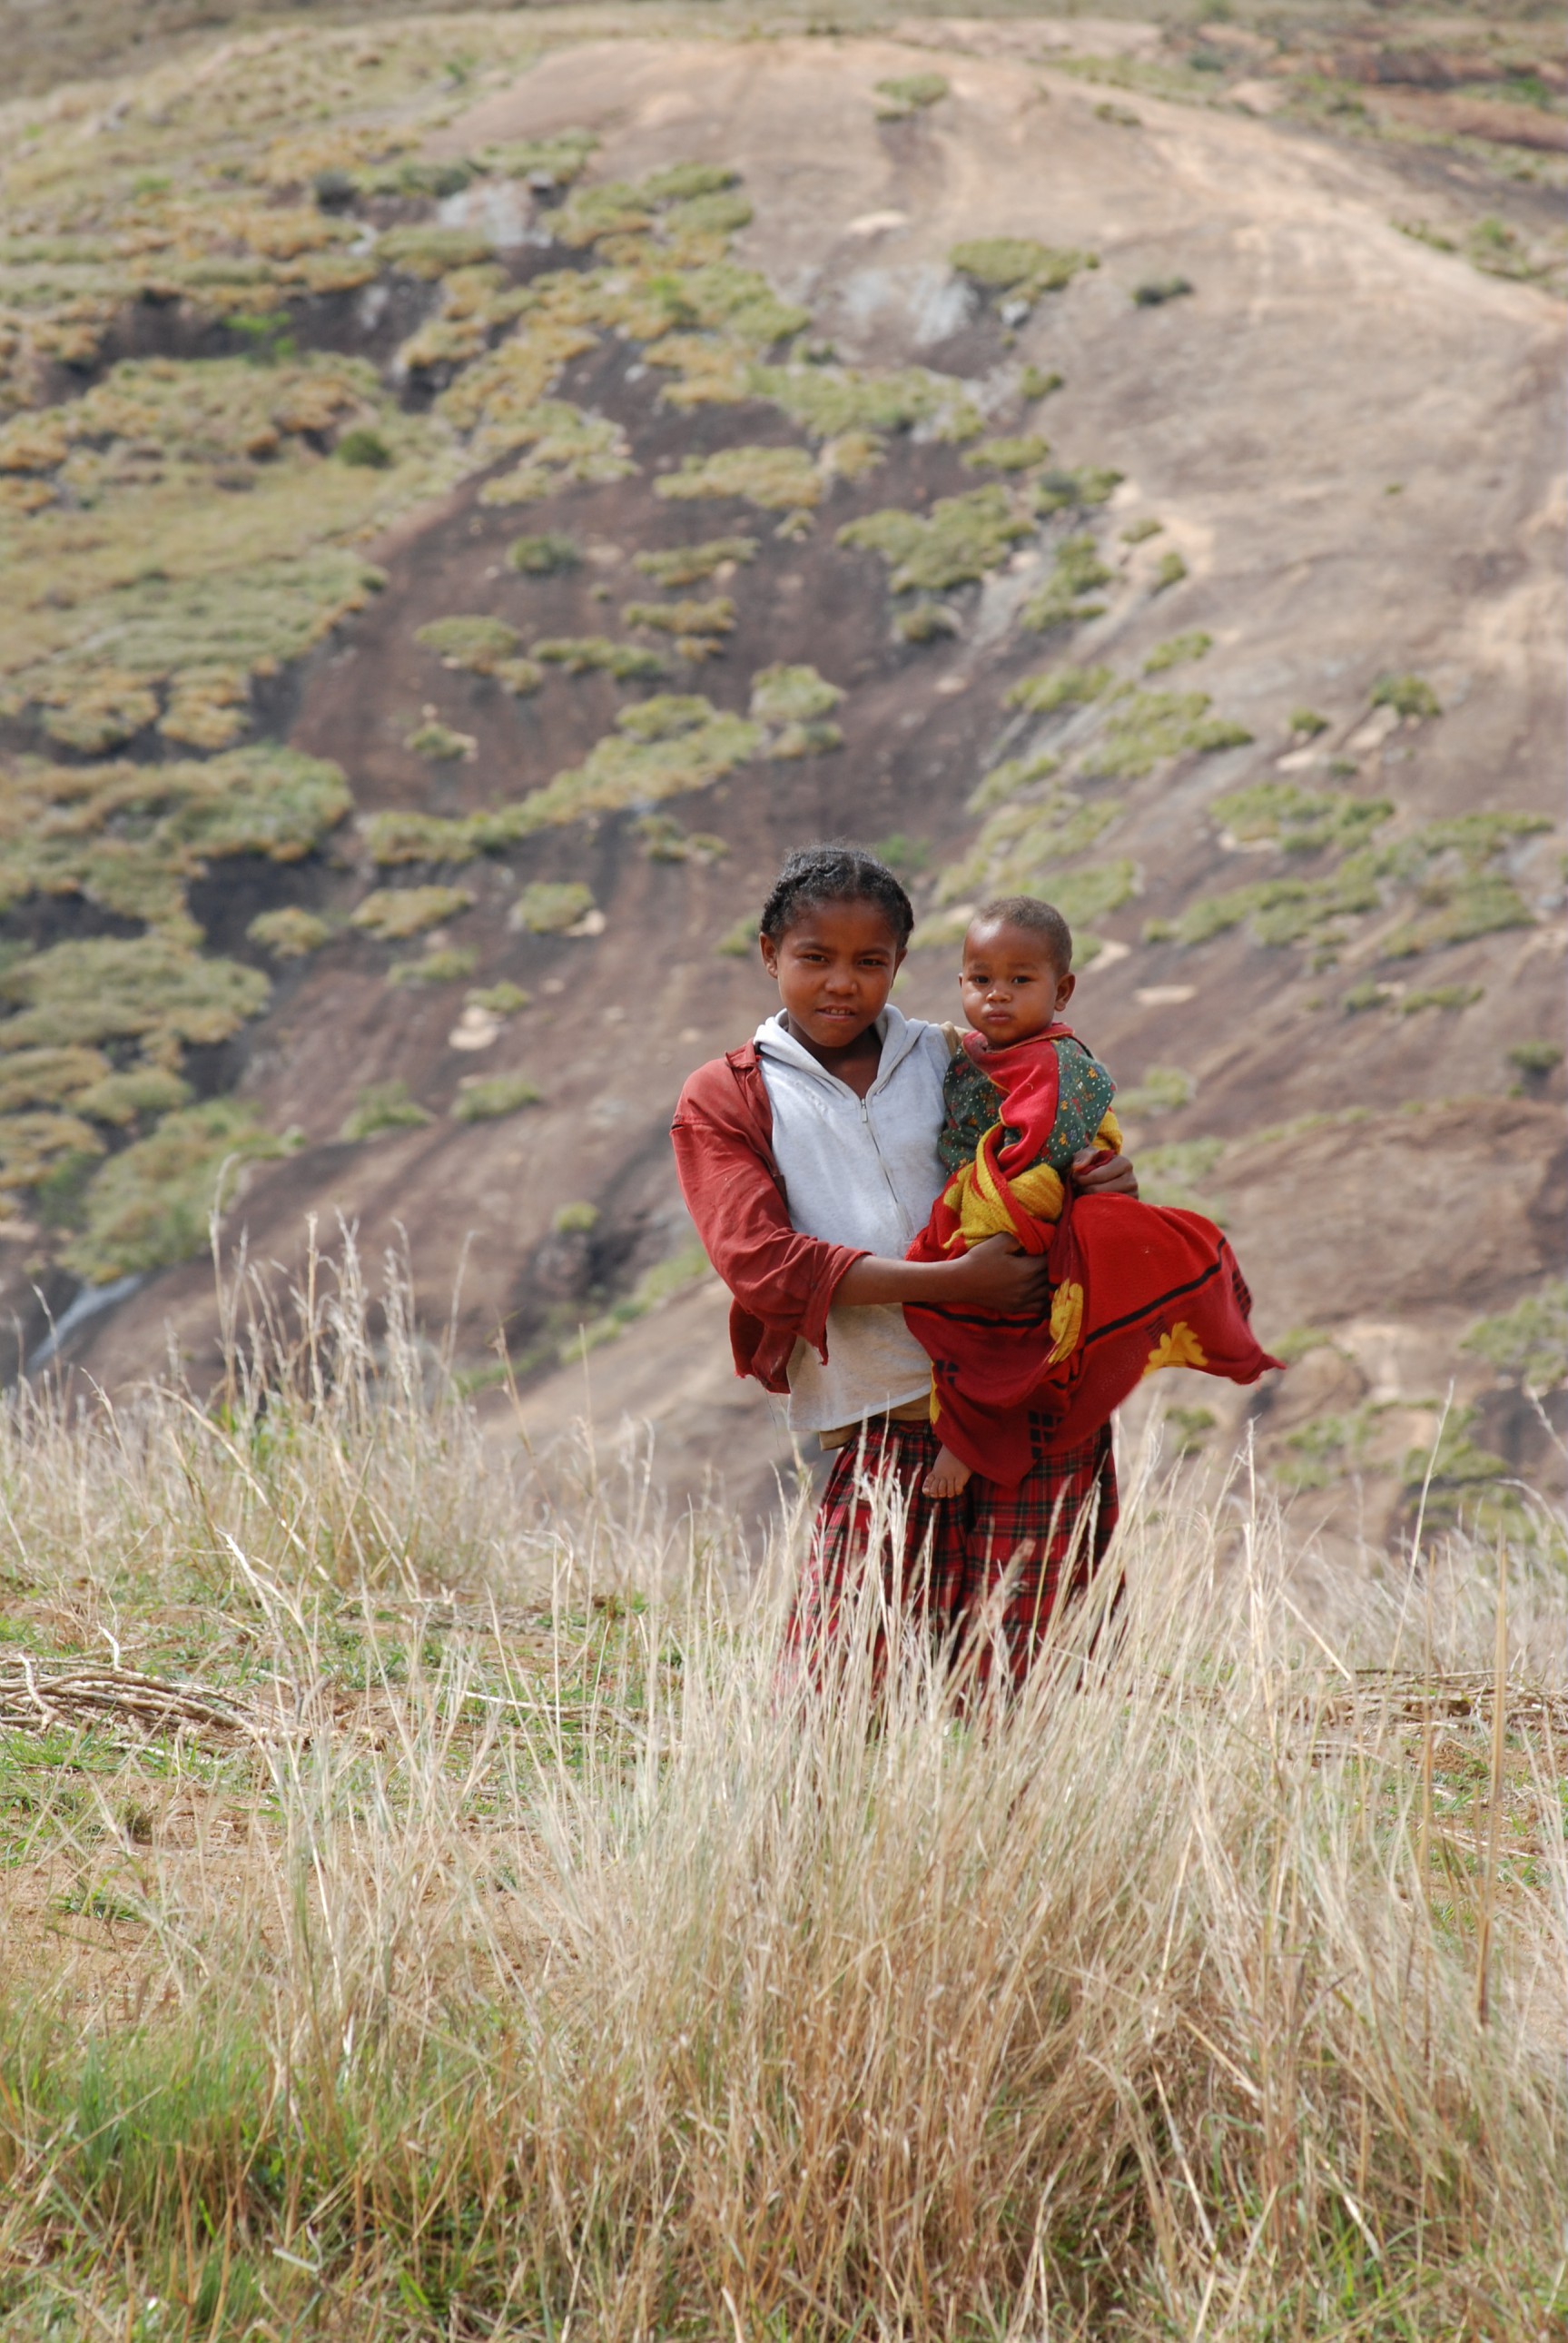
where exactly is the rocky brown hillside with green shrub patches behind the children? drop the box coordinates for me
[0,12,1565,1535]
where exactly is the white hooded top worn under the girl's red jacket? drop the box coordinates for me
[754,1007,949,1431]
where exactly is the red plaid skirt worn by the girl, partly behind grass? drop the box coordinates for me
[787,1422,1118,1682]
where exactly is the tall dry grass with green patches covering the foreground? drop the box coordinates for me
[0,1253,1568,2343]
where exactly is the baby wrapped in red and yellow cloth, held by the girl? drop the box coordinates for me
[904,895,1279,1498]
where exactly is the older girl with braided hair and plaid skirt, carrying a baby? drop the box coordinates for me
[670,845,1137,1677]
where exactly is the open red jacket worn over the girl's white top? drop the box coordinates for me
[670,1041,867,1392]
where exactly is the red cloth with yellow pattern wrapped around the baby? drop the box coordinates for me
[904,1026,1279,1483]
